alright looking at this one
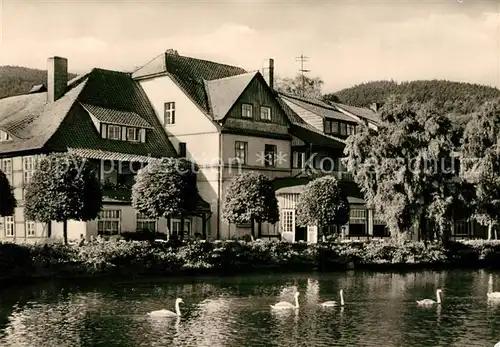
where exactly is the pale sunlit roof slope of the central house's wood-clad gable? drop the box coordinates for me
[205,72,257,120]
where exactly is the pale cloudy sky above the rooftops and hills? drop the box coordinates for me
[0,0,500,93]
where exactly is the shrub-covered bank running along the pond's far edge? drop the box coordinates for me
[0,241,500,280]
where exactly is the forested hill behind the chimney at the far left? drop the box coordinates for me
[0,65,76,99]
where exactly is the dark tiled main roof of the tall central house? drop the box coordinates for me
[132,52,247,119]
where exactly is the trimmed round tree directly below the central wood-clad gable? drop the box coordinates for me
[222,172,279,237]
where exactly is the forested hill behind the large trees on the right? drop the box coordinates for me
[325,80,500,114]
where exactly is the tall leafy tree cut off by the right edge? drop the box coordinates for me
[460,98,500,239]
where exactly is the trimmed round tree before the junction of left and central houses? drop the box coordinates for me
[132,158,198,241]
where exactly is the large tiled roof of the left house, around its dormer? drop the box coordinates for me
[0,69,177,157]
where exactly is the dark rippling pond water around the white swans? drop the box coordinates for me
[0,271,500,347]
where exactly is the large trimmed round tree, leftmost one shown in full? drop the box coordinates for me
[24,153,102,244]
